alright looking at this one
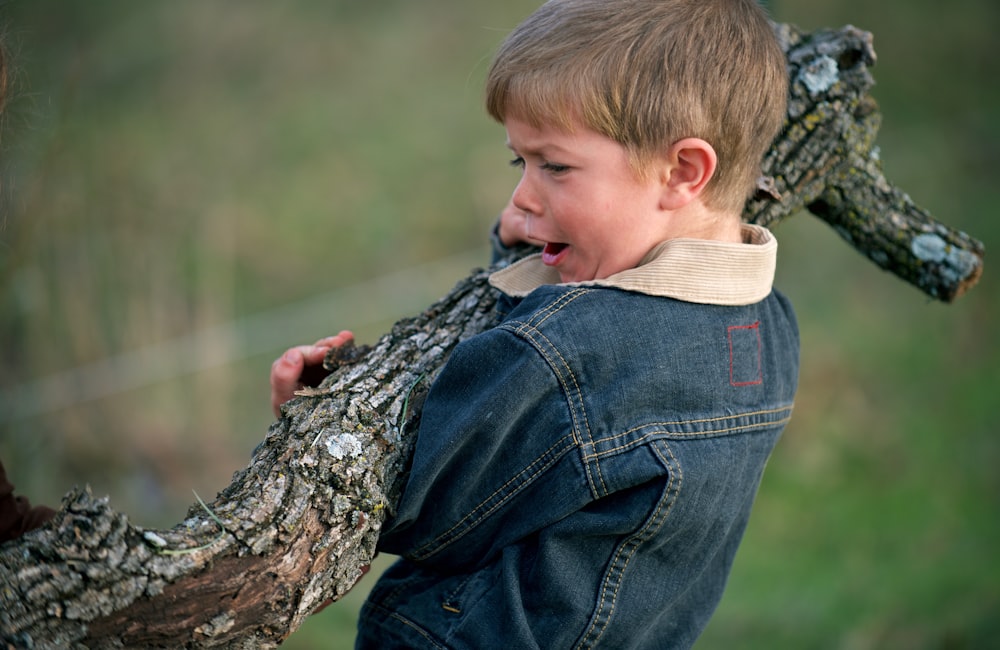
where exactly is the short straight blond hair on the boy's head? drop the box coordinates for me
[486,0,788,212]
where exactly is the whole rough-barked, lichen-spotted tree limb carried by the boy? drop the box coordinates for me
[0,25,983,648]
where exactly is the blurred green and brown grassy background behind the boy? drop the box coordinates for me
[0,0,1000,650]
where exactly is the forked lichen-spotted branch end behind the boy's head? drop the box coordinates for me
[745,25,985,302]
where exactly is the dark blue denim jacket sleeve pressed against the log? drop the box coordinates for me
[379,329,591,568]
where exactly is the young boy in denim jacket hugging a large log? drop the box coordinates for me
[271,0,798,649]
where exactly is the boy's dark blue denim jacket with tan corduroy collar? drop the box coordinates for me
[357,226,799,650]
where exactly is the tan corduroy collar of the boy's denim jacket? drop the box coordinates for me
[490,224,778,305]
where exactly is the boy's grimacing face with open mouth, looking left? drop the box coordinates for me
[504,118,670,282]
